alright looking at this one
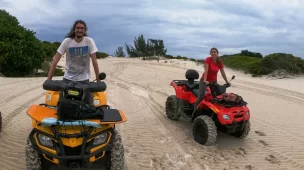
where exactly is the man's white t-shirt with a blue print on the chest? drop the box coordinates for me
[57,36,98,81]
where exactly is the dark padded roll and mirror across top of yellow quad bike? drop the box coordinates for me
[43,72,107,92]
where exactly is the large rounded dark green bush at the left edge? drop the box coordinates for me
[0,10,45,76]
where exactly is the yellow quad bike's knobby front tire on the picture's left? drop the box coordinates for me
[25,139,49,170]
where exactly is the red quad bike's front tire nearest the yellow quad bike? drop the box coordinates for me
[192,115,217,146]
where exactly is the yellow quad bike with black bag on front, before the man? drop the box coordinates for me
[26,73,127,170]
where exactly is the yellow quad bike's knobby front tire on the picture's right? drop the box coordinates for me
[104,130,125,170]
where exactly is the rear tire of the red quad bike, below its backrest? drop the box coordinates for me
[166,95,181,120]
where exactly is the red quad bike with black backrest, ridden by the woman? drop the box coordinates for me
[166,69,250,146]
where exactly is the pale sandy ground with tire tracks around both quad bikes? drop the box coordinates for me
[0,58,304,170]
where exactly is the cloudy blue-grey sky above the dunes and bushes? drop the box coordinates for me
[0,0,304,59]
